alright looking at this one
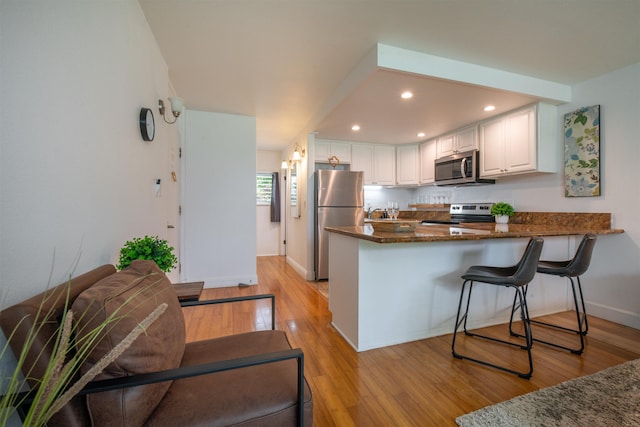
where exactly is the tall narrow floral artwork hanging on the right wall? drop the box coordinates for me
[564,105,600,197]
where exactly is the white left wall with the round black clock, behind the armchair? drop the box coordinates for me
[0,1,178,307]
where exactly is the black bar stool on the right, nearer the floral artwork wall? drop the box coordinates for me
[509,234,596,355]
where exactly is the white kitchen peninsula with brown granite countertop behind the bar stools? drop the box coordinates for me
[327,212,623,351]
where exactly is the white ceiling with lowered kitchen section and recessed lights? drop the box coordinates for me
[139,0,640,151]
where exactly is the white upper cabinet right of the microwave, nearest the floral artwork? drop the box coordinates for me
[479,103,559,177]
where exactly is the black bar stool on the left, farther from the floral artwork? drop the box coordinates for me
[451,237,544,379]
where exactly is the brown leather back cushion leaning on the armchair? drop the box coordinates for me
[72,260,185,426]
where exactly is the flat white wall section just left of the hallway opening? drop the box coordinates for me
[181,110,258,288]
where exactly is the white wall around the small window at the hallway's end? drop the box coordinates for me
[256,151,286,256]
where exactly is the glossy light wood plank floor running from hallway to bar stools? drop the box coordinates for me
[185,257,640,427]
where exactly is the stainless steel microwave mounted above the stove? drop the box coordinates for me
[435,150,495,186]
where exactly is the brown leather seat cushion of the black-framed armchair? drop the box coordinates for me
[145,330,313,427]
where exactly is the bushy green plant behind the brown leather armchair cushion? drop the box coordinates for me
[117,236,178,273]
